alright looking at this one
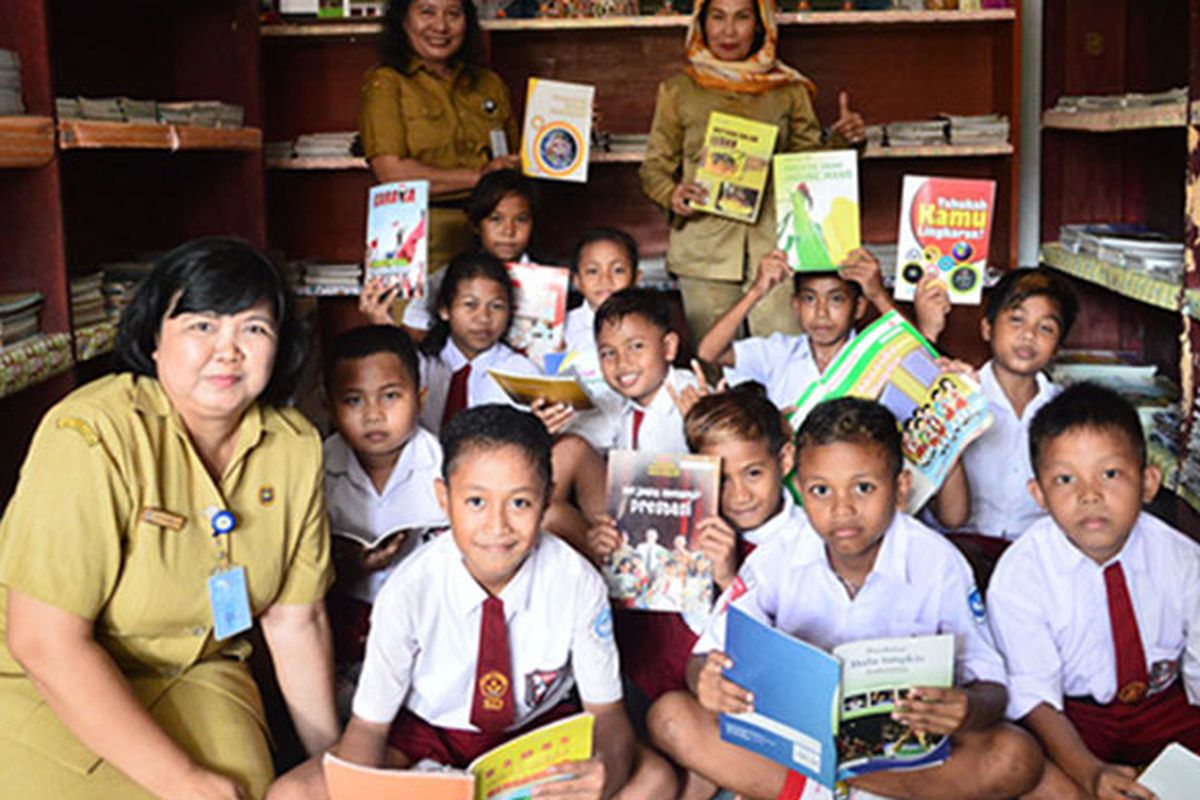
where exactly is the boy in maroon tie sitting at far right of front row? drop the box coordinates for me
[988,384,1200,799]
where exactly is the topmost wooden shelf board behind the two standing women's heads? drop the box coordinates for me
[262,8,1016,38]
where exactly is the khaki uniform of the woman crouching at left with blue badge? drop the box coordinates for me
[0,374,332,800]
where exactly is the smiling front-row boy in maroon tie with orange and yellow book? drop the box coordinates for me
[267,405,674,799]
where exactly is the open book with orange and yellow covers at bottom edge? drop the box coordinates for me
[324,711,595,800]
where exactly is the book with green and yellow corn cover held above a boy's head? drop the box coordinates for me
[774,150,862,272]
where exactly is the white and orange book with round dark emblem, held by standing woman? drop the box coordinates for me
[521,78,595,184]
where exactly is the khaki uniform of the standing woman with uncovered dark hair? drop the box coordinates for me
[359,59,518,269]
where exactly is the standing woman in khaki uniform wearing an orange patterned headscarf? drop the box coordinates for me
[640,0,866,342]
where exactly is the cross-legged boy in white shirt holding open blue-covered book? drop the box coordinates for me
[649,398,1042,798]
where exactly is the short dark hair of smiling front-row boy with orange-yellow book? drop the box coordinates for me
[442,403,552,492]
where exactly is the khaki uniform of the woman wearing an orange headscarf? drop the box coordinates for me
[638,73,821,282]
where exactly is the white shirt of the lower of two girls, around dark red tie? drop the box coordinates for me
[421,339,541,433]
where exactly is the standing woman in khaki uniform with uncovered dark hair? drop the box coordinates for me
[359,0,520,284]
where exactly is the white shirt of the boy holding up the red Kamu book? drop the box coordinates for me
[962,361,1062,540]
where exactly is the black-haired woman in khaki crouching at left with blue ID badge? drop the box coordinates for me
[0,239,337,800]
